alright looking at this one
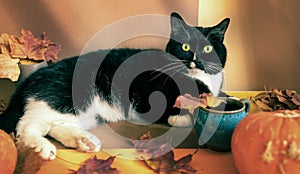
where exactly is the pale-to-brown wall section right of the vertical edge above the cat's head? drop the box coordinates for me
[199,0,300,92]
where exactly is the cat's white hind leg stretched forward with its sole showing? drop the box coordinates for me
[48,123,101,152]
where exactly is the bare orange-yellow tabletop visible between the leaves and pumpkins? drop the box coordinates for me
[39,91,258,174]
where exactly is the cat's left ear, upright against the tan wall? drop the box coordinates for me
[171,12,187,35]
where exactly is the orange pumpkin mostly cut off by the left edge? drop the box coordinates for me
[0,130,17,174]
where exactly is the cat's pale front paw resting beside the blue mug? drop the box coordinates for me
[168,114,193,127]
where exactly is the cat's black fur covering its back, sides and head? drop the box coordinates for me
[0,13,229,132]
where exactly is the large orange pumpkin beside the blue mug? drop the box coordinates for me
[231,110,300,174]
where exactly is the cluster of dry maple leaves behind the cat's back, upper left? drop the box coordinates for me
[0,29,61,81]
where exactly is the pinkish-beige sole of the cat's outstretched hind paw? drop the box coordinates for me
[76,137,101,152]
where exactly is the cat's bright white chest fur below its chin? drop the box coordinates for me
[188,68,223,96]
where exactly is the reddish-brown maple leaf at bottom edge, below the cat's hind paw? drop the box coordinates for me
[70,155,119,174]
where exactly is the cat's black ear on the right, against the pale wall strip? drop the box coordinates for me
[207,18,230,42]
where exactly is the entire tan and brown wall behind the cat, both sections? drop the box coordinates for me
[0,0,300,98]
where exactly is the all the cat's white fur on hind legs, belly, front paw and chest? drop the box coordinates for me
[16,69,223,160]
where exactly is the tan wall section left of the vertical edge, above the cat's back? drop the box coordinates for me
[0,0,198,100]
